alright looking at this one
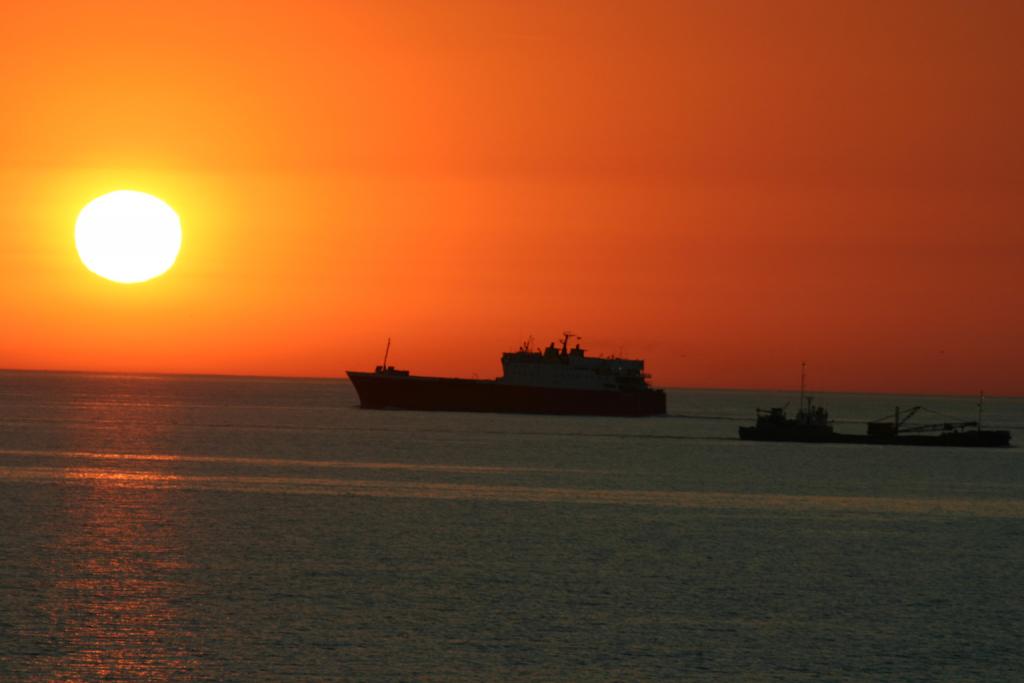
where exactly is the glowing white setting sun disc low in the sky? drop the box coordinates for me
[75,189,181,284]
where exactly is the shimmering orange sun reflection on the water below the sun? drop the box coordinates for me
[36,397,201,681]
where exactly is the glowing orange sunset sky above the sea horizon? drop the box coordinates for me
[0,0,1024,395]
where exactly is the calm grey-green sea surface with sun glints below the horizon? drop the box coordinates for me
[0,373,1024,681]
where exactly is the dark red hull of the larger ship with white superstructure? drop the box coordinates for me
[348,371,665,417]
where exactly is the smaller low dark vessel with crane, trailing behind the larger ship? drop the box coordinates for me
[739,369,1011,447]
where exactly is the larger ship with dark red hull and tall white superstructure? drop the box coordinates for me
[348,333,665,416]
